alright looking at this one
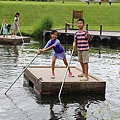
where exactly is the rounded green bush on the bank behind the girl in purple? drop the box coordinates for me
[32,17,53,39]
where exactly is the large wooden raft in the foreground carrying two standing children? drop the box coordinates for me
[24,66,106,94]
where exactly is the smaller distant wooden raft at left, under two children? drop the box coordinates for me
[0,35,30,45]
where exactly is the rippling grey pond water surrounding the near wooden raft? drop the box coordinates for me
[0,43,120,120]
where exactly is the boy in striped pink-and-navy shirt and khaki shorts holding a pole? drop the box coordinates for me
[73,19,92,80]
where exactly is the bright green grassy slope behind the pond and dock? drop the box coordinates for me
[0,0,120,34]
